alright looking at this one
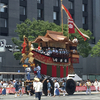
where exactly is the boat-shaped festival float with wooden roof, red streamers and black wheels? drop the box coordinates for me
[21,1,88,95]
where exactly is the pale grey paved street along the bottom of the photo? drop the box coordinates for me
[0,92,100,100]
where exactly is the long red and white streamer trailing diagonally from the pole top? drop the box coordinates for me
[62,4,90,41]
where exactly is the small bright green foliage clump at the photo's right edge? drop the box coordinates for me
[91,40,100,57]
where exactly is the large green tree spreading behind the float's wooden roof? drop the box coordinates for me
[12,19,93,60]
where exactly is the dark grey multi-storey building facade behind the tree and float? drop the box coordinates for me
[0,0,100,77]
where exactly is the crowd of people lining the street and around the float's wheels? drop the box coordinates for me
[0,79,100,97]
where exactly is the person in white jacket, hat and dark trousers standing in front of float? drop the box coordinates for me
[34,78,43,100]
